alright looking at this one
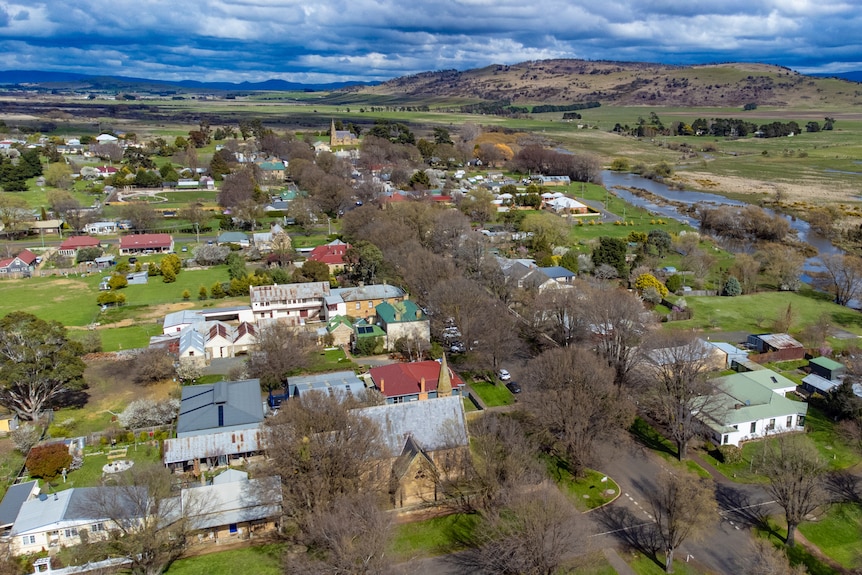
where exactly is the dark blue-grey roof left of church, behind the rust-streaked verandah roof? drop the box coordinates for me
[177,379,263,437]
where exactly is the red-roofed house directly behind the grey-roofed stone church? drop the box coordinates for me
[371,356,465,403]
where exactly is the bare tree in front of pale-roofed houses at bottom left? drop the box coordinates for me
[80,463,202,575]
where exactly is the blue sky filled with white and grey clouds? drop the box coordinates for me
[0,0,862,83]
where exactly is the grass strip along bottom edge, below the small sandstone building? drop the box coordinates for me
[165,544,284,575]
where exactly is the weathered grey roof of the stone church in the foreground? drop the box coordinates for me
[355,396,468,457]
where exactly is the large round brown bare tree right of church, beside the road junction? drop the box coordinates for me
[523,347,634,476]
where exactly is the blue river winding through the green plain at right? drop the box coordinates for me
[602,170,844,283]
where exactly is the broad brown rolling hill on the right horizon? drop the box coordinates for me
[342,60,862,107]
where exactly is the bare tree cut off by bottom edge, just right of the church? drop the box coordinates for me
[455,483,589,575]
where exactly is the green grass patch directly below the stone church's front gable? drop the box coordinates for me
[389,513,479,561]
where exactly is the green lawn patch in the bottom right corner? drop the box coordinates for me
[799,503,862,569]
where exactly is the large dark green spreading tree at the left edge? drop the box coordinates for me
[0,312,85,420]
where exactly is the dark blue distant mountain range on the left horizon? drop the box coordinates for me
[0,70,374,92]
